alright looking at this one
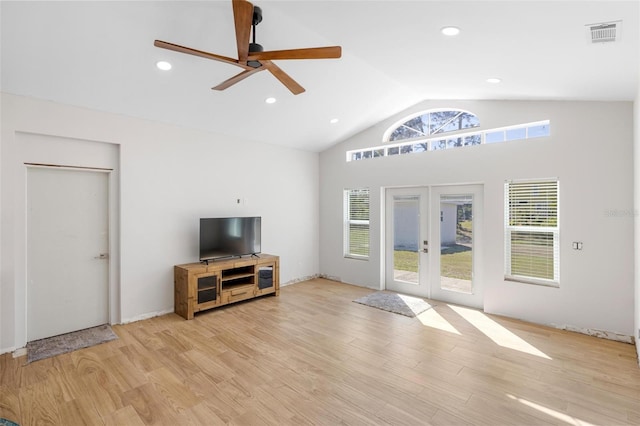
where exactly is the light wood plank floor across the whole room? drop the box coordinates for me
[0,279,640,426]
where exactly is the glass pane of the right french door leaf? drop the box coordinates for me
[440,194,473,293]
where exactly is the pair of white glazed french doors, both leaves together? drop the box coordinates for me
[385,185,483,308]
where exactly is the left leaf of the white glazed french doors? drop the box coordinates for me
[385,187,429,297]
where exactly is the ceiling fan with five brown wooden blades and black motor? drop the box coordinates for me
[153,0,342,95]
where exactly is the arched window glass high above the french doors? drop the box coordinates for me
[383,110,480,142]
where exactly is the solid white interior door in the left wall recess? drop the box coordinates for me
[27,167,109,341]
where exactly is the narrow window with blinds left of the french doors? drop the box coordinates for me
[344,189,369,259]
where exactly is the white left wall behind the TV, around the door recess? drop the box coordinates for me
[0,94,319,353]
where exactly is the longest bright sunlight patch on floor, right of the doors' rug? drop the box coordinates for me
[447,305,551,359]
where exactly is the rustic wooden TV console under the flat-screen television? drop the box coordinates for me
[173,254,280,320]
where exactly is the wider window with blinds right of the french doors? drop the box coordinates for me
[505,180,560,286]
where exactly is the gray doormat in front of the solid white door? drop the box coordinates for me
[27,324,118,364]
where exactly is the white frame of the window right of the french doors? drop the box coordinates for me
[504,178,560,287]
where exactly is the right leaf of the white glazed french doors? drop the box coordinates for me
[429,185,483,308]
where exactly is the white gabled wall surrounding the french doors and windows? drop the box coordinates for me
[320,101,634,338]
